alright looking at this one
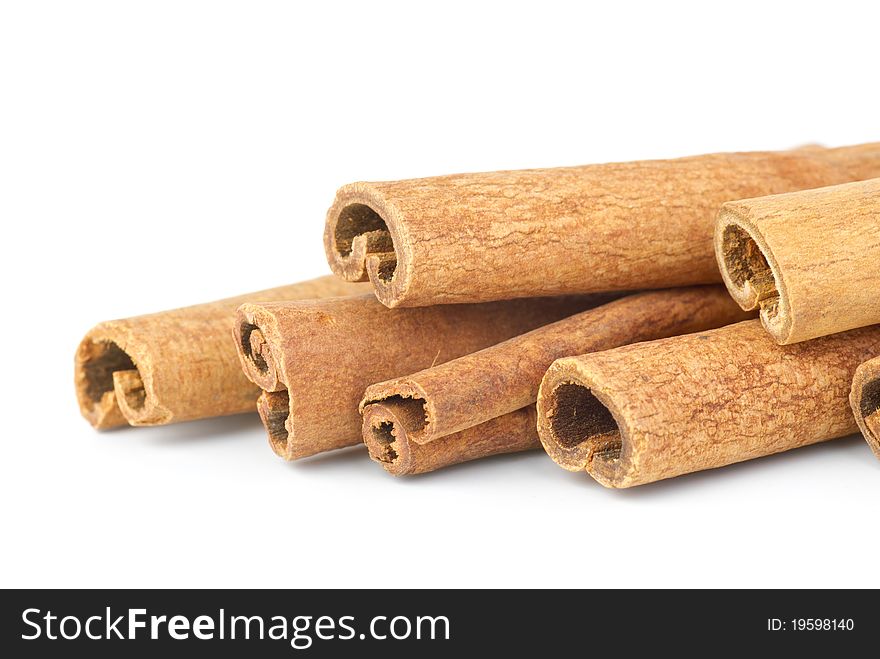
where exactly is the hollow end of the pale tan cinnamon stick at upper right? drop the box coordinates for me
[715,210,792,345]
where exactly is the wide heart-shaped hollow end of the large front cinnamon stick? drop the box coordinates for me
[538,359,630,487]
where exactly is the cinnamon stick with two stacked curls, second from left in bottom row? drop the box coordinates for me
[235,295,604,460]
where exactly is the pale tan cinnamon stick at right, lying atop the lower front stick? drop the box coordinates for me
[715,178,880,344]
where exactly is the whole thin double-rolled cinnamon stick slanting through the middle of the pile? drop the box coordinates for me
[361,286,750,475]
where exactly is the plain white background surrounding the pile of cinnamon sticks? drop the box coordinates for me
[0,0,880,587]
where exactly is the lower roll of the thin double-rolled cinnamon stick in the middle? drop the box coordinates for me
[363,401,541,476]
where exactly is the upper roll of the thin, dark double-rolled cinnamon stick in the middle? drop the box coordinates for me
[361,286,750,452]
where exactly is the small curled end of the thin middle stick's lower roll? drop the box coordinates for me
[363,400,421,476]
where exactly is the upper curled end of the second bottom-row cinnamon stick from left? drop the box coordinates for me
[232,304,287,391]
